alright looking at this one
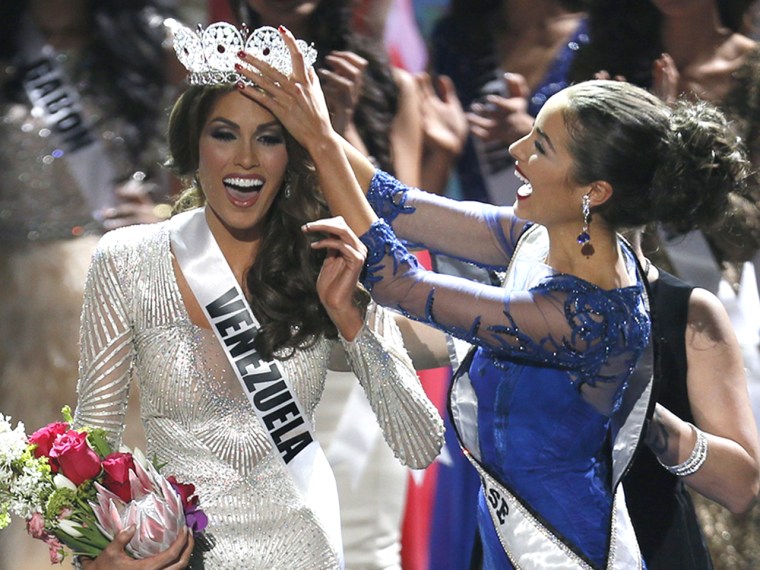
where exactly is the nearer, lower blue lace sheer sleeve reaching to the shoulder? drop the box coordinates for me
[361,220,649,385]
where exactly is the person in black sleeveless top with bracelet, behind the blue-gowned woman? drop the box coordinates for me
[623,230,760,570]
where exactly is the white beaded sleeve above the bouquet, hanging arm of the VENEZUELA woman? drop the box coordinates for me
[74,235,134,446]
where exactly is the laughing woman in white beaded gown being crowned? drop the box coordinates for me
[76,23,443,570]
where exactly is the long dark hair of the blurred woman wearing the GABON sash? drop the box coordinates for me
[0,0,176,164]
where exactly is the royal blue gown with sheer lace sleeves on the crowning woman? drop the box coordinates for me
[361,172,650,569]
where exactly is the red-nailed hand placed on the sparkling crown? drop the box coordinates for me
[235,27,337,156]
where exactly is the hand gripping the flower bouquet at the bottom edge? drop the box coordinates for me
[81,527,195,570]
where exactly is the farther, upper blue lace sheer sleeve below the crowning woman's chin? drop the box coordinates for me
[367,170,527,269]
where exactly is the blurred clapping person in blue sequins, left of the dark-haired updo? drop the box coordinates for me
[430,0,587,205]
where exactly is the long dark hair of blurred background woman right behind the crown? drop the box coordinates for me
[230,0,399,173]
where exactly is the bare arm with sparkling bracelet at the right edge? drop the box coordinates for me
[647,289,760,513]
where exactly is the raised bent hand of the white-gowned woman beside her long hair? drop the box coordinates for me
[303,216,367,340]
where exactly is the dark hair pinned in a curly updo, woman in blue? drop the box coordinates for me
[564,81,749,233]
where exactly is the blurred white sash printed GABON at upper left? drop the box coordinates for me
[19,15,116,221]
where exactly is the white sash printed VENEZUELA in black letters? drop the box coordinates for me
[168,208,343,566]
